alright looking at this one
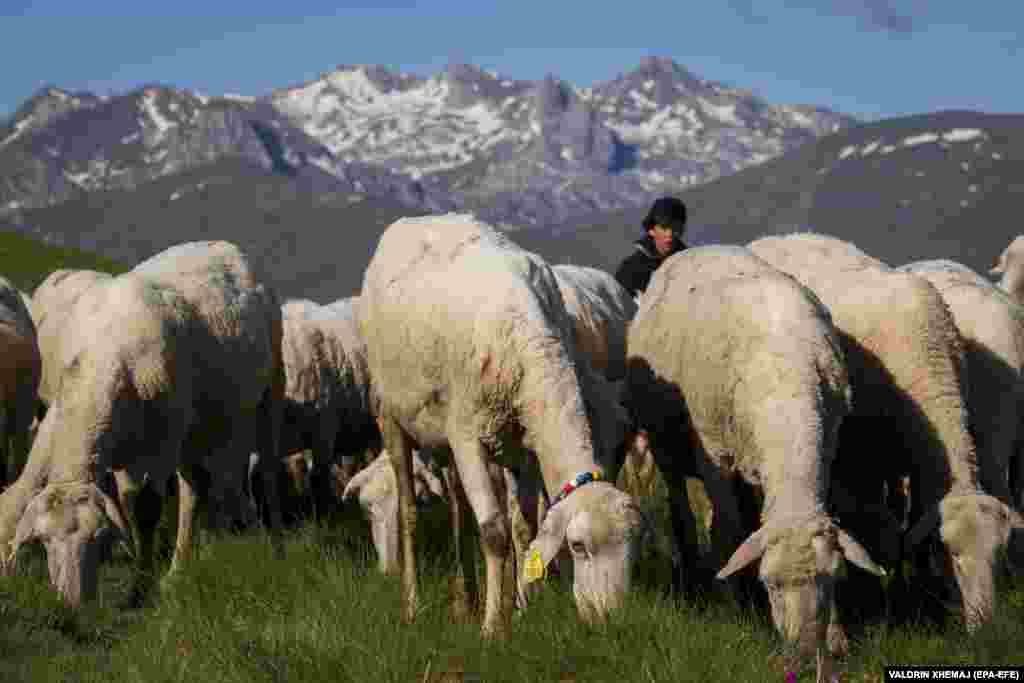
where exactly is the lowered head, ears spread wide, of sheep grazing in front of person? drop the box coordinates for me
[718,515,885,655]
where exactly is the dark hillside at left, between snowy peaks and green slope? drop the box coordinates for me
[0,159,424,302]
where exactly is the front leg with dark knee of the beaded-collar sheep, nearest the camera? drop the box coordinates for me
[452,437,510,637]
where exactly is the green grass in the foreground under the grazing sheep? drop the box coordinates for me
[0,479,1024,683]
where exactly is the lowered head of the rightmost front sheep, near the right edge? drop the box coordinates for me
[905,493,1024,631]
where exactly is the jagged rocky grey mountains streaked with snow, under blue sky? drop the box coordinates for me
[0,57,857,226]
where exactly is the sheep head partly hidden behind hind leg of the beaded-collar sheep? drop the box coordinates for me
[342,451,445,573]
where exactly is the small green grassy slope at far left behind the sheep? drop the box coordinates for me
[0,227,128,295]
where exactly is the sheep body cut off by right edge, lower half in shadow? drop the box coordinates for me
[898,260,1024,505]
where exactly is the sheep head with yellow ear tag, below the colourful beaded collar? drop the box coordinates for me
[518,481,653,621]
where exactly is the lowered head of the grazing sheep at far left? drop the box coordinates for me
[11,483,130,607]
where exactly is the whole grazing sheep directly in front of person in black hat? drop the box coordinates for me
[628,246,882,667]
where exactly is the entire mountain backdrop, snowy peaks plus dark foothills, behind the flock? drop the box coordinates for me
[0,59,1024,302]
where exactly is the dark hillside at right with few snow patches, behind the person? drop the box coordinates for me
[544,112,1024,272]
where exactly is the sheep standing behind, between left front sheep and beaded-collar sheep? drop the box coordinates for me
[282,300,380,512]
